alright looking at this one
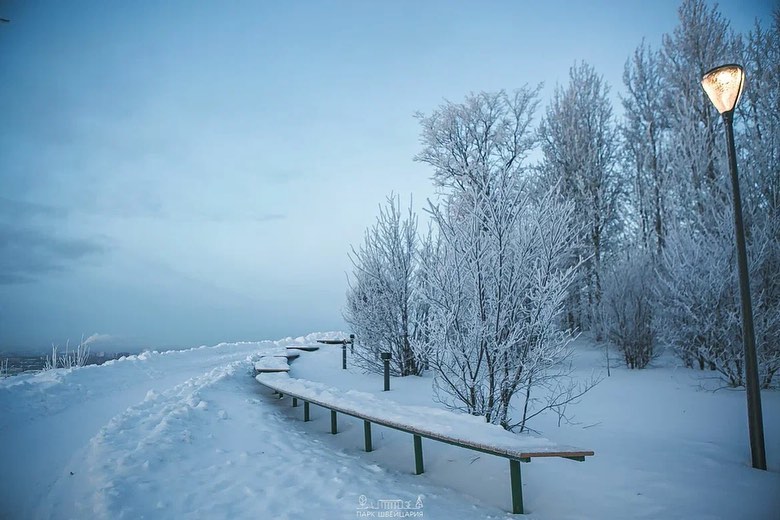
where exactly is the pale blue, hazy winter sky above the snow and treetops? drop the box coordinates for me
[0,0,776,352]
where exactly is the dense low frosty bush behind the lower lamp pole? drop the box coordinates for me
[659,210,780,388]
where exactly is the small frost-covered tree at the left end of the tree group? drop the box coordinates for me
[344,196,427,376]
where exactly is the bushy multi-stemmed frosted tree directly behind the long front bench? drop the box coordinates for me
[424,183,592,431]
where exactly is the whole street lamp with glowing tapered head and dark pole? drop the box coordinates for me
[701,64,766,470]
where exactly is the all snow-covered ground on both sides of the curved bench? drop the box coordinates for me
[0,334,780,519]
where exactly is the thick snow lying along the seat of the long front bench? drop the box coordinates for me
[256,374,593,460]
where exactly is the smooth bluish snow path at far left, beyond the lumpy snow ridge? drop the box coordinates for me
[0,342,275,517]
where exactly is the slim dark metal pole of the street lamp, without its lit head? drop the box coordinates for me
[723,111,766,470]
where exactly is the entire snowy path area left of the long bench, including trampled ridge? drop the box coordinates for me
[0,342,507,518]
